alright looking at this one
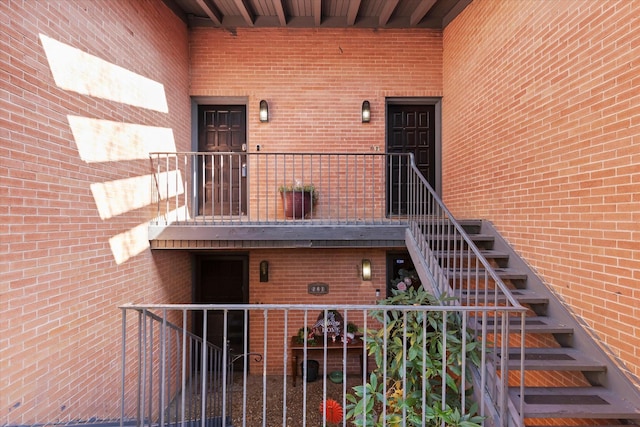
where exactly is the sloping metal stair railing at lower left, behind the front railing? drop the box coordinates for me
[121,305,238,426]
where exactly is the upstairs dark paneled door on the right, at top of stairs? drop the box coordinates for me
[387,104,436,215]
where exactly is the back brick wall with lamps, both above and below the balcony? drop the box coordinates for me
[190,28,442,372]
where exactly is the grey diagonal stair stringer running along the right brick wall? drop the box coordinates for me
[480,220,640,412]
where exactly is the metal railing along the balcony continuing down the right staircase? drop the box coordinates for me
[144,153,525,425]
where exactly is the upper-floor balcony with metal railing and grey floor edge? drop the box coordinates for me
[149,152,416,249]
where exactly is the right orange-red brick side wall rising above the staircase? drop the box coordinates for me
[443,0,640,382]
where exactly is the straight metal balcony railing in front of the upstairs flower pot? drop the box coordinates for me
[150,152,411,225]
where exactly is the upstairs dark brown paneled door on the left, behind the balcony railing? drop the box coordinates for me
[198,105,247,215]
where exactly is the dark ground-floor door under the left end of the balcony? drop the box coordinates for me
[194,255,249,370]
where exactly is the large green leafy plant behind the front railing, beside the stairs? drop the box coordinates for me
[346,287,482,427]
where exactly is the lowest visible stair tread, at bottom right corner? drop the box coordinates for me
[509,387,640,419]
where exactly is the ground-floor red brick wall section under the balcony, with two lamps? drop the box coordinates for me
[249,249,387,374]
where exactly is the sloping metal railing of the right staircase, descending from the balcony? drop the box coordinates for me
[396,154,526,426]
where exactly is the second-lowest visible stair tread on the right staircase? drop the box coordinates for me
[498,347,606,372]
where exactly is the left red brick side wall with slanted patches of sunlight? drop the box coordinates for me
[0,0,191,425]
